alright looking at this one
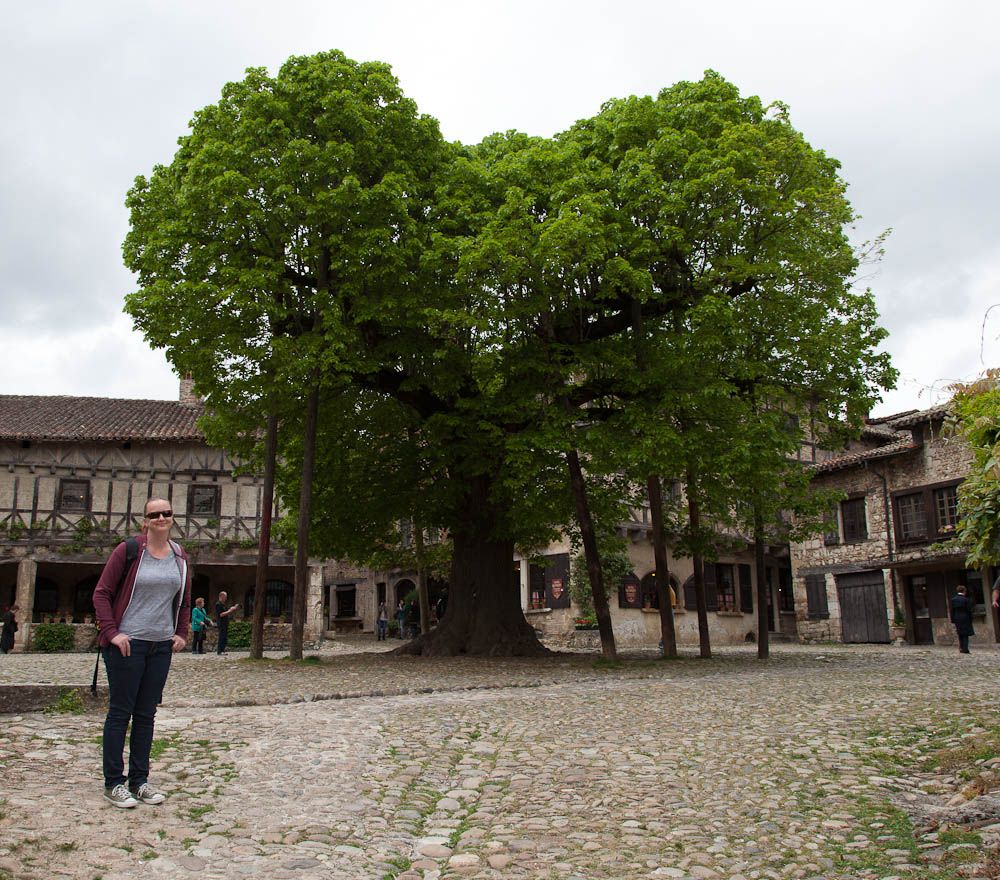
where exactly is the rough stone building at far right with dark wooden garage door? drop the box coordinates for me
[791,405,1000,644]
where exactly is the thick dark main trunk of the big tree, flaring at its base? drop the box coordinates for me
[396,475,550,657]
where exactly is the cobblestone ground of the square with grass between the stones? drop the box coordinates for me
[0,642,1000,880]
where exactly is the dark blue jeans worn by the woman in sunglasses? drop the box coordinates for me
[102,639,173,788]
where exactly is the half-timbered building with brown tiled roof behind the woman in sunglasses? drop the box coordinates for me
[0,386,326,647]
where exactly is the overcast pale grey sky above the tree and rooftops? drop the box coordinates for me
[0,0,1000,414]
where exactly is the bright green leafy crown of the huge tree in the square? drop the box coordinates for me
[124,51,892,648]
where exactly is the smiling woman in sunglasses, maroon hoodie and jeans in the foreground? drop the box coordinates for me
[94,498,191,807]
